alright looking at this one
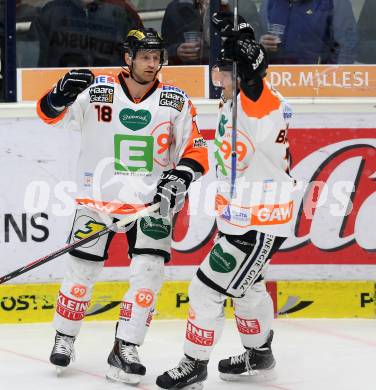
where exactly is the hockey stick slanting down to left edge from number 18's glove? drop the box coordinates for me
[0,203,160,284]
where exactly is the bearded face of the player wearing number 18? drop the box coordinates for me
[132,50,161,82]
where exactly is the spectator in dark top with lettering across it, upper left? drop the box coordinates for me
[30,0,142,67]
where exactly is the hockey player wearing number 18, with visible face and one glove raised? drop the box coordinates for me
[37,29,208,384]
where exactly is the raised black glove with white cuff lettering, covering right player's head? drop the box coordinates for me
[223,34,268,81]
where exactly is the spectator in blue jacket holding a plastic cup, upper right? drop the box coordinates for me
[260,0,357,64]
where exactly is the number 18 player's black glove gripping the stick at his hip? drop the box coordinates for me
[154,169,193,217]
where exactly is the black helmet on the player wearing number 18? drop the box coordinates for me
[123,28,167,65]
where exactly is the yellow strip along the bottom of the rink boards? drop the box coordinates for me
[0,281,376,323]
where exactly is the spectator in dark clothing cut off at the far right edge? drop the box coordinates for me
[358,0,376,64]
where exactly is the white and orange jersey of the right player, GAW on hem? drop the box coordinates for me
[214,80,295,237]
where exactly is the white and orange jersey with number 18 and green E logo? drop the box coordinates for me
[37,72,208,214]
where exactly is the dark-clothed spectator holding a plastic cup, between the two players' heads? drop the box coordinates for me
[162,0,229,65]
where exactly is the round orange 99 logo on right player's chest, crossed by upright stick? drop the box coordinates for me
[218,130,255,172]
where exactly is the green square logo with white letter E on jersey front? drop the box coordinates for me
[114,134,154,173]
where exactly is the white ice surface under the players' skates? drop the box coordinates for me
[0,319,376,390]
